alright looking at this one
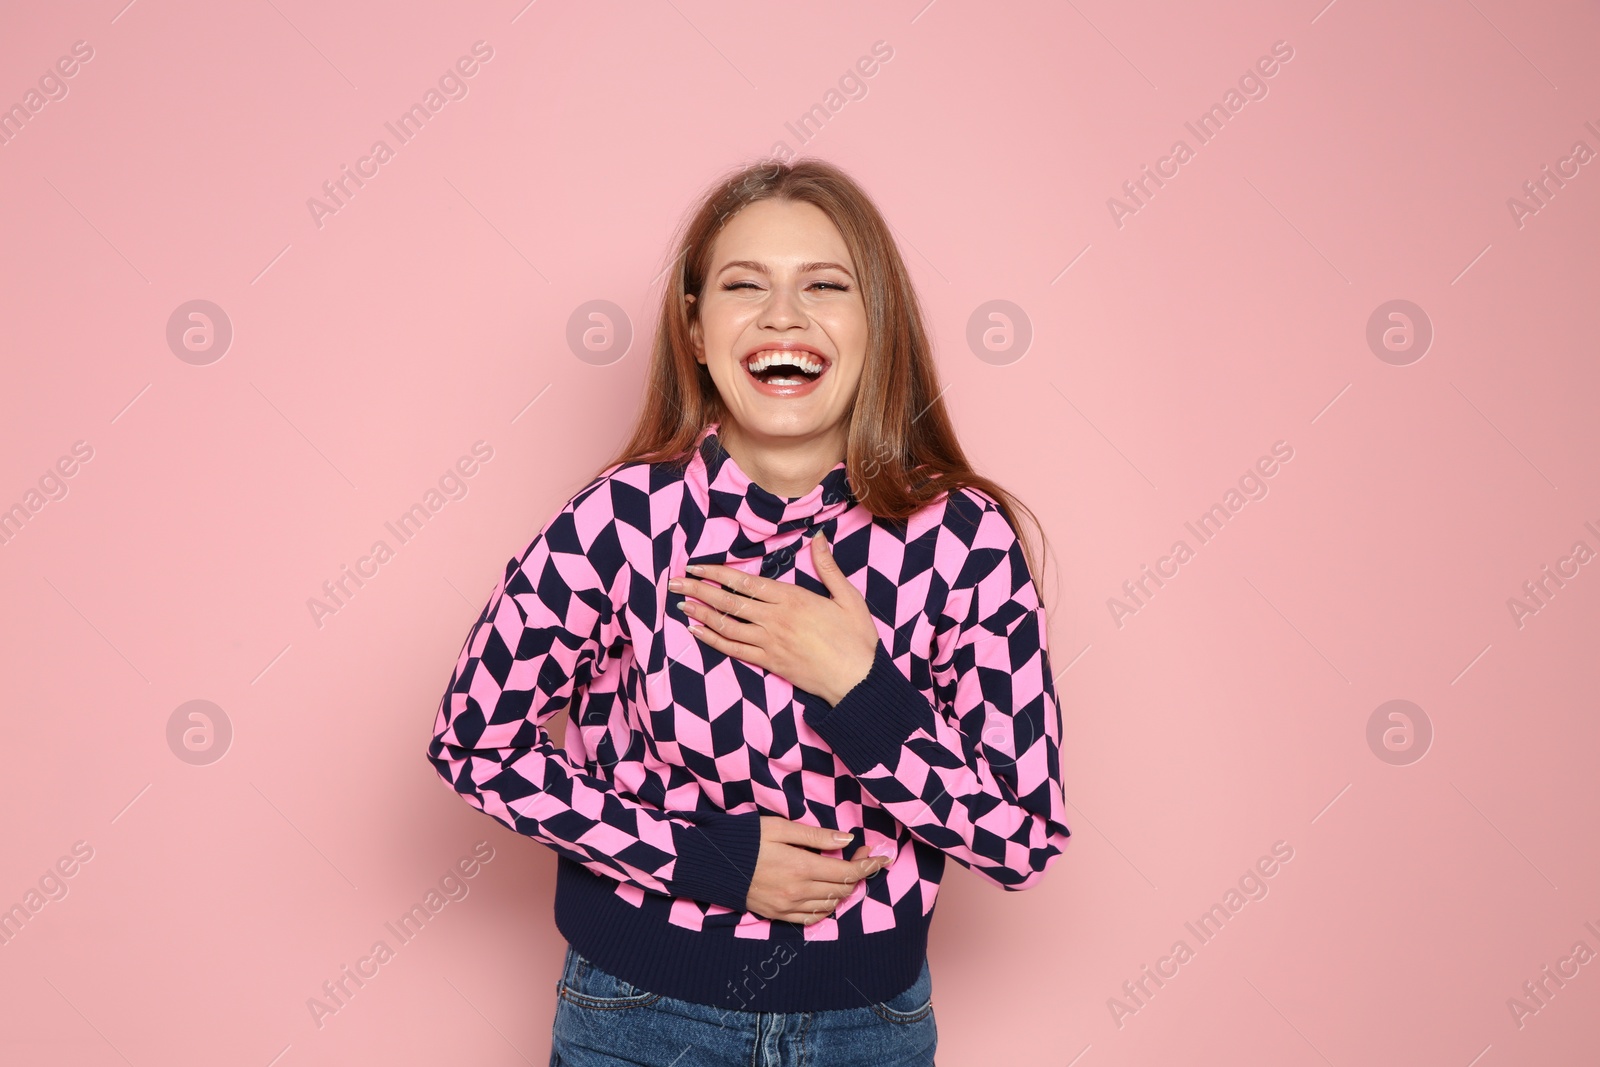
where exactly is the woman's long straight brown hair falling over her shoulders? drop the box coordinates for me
[602,158,1048,587]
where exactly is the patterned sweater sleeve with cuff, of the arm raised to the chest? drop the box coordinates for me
[802,496,1070,889]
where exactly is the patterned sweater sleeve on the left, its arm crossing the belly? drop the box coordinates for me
[427,475,760,912]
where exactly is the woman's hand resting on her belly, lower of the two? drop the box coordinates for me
[744,816,890,926]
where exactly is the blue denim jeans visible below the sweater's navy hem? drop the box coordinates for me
[550,945,939,1067]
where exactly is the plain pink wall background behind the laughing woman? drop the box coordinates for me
[0,0,1600,1067]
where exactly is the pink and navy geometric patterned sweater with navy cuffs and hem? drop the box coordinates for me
[427,422,1069,1011]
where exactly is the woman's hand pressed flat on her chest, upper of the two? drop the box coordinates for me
[667,533,878,705]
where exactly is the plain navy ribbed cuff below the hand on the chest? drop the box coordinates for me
[800,640,934,774]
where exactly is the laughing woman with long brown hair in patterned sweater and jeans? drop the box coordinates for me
[429,160,1069,1067]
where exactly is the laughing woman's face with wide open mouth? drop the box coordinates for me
[690,200,867,442]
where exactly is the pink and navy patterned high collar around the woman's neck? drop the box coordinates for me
[683,422,856,577]
